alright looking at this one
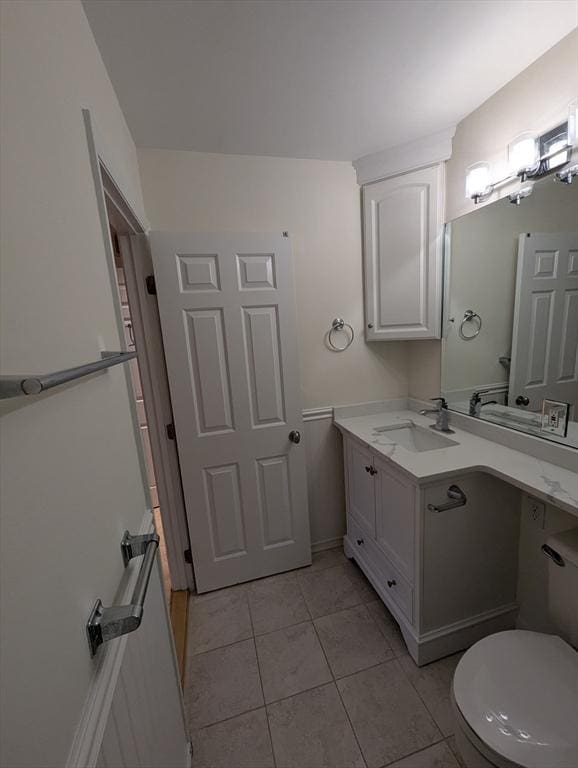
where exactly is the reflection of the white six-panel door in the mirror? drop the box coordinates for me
[510,232,578,418]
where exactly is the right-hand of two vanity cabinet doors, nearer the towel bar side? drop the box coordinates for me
[375,459,416,584]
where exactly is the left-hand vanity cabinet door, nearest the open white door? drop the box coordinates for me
[345,440,377,538]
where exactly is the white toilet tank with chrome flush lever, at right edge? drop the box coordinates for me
[542,528,578,648]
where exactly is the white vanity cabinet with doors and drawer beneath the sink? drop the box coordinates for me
[344,435,520,664]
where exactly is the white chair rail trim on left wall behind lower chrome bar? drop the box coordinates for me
[66,510,154,768]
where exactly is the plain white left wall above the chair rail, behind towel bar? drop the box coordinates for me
[0,0,151,768]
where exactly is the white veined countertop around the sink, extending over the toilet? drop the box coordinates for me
[335,410,578,516]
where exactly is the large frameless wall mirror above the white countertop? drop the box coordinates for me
[442,176,578,448]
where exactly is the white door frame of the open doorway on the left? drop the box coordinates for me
[82,109,195,591]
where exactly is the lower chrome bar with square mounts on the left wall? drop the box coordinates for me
[86,531,159,656]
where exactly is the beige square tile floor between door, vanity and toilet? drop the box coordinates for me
[185,549,460,768]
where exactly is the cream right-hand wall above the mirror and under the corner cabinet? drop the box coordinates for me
[408,30,578,398]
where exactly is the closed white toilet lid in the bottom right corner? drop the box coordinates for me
[453,630,578,768]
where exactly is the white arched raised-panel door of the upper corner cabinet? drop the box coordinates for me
[363,163,444,341]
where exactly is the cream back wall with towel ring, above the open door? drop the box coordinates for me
[138,149,407,408]
